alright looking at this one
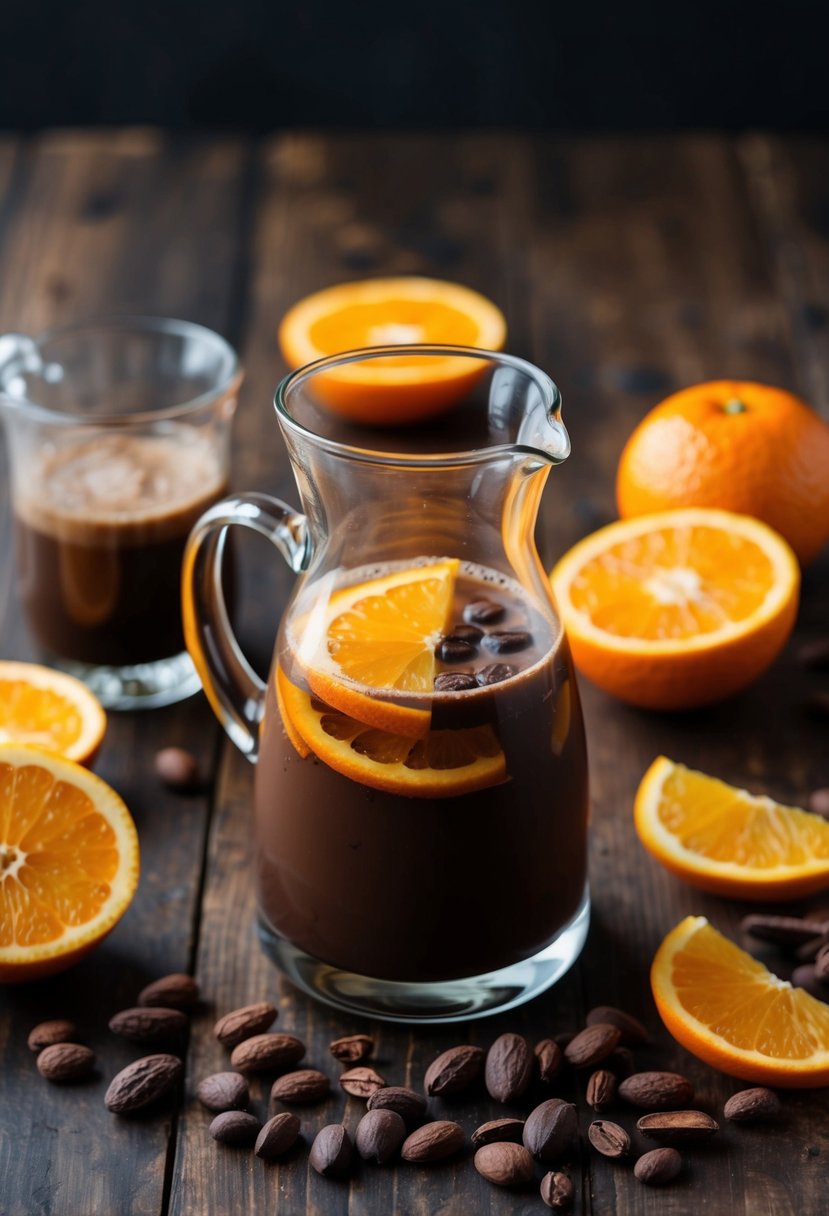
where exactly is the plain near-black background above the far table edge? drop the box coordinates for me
[0,0,829,131]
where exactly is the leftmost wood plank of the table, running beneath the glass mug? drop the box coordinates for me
[0,131,247,1216]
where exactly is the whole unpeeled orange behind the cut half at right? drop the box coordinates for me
[616,381,829,564]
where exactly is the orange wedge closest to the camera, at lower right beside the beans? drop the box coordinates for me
[650,916,829,1088]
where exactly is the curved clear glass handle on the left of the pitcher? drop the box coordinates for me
[181,494,311,762]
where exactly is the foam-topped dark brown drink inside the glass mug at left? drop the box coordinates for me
[15,435,226,666]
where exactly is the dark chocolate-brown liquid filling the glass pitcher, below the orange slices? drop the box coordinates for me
[255,580,587,983]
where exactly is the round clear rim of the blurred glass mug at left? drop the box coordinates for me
[0,315,242,427]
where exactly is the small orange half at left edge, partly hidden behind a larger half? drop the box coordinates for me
[0,659,107,764]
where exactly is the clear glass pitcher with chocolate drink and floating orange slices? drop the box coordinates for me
[182,347,590,1023]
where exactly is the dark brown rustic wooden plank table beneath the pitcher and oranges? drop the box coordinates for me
[0,130,829,1216]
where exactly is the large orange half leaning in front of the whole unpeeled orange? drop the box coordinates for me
[551,507,800,709]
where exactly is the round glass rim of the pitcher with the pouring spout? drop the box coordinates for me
[273,343,562,468]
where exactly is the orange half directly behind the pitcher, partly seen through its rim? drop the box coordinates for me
[278,277,507,426]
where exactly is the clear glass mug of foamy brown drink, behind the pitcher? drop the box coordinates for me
[0,317,242,709]
